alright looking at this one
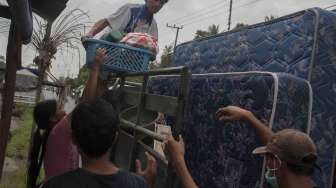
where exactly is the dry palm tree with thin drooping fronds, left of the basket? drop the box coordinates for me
[30,9,88,102]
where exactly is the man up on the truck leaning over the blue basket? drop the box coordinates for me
[84,0,168,39]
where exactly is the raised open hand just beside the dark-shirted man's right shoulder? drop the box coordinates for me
[135,152,157,188]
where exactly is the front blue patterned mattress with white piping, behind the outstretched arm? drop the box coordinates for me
[149,72,312,188]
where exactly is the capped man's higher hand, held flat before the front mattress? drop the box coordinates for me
[216,106,250,121]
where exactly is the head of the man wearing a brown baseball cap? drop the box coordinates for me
[253,129,317,187]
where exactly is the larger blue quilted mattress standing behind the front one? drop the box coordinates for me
[173,8,336,187]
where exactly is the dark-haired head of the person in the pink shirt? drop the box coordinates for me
[34,100,66,130]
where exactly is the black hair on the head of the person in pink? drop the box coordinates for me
[34,100,57,130]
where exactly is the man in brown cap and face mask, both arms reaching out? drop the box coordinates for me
[165,106,317,188]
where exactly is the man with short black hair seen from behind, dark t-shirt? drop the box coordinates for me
[43,99,148,188]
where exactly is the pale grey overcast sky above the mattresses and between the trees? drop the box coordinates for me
[0,0,336,76]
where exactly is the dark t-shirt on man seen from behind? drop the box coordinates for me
[42,169,148,188]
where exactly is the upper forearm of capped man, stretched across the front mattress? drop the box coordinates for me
[245,111,273,144]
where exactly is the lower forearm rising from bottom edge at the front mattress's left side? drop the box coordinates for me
[173,158,198,188]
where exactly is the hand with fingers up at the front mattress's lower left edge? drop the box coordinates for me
[164,135,184,165]
